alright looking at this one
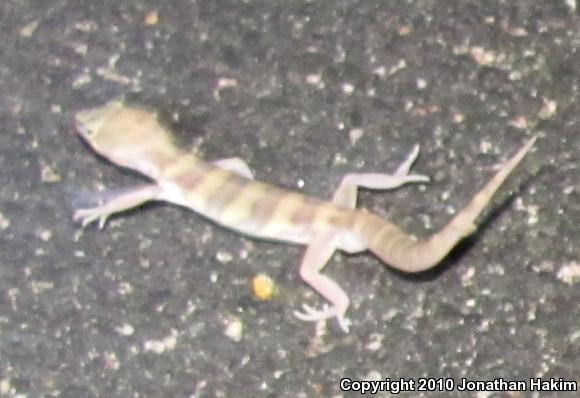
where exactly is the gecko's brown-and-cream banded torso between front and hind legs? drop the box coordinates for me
[164,157,355,243]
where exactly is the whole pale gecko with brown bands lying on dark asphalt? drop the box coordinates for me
[73,101,537,332]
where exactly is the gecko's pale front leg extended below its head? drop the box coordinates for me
[73,184,161,229]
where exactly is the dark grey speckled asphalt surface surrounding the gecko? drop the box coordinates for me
[0,0,580,398]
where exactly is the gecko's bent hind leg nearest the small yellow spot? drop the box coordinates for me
[294,231,350,333]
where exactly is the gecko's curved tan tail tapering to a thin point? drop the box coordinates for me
[369,136,537,272]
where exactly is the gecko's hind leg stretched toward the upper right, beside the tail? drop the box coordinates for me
[332,145,429,209]
